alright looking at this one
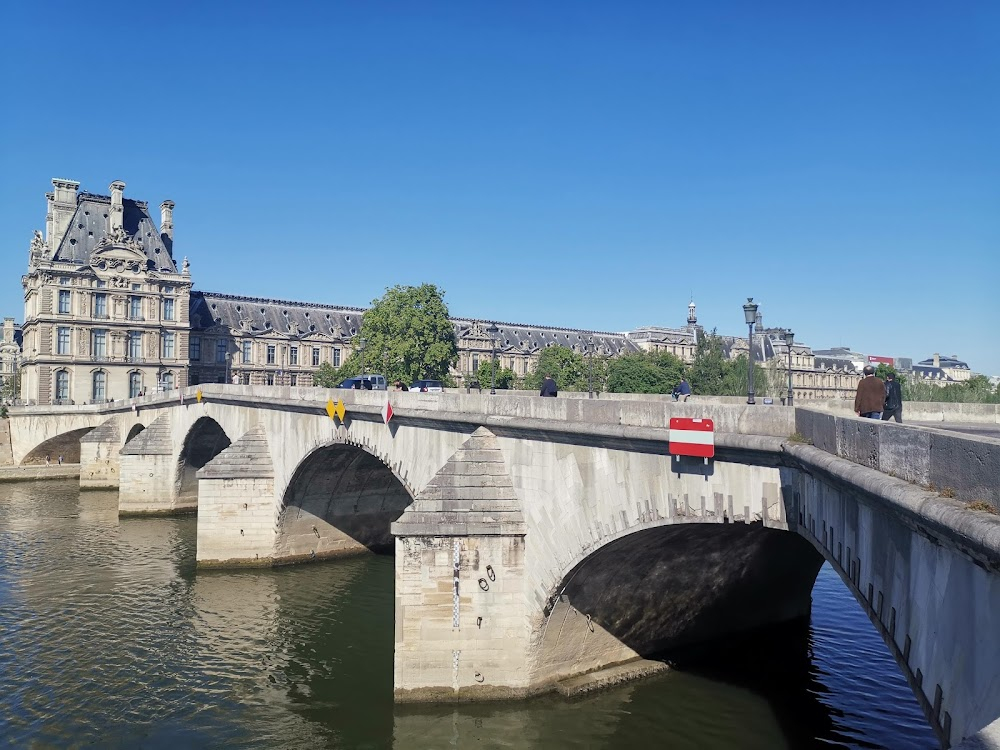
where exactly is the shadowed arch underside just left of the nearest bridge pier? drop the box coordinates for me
[275,443,413,563]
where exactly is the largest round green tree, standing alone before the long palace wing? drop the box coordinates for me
[356,284,458,385]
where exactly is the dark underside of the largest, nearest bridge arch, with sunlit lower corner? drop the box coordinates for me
[534,523,823,679]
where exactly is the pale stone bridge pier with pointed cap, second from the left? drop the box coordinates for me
[118,415,189,516]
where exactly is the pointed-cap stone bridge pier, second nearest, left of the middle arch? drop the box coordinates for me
[196,425,276,567]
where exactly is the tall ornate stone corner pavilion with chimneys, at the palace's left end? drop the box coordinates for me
[20,179,191,404]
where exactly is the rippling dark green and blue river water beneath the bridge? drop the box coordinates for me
[0,481,937,750]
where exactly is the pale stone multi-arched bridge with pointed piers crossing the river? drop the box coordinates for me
[1,385,1000,747]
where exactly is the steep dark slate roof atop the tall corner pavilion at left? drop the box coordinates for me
[52,193,177,273]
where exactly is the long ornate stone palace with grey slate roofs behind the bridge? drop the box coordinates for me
[13,179,857,404]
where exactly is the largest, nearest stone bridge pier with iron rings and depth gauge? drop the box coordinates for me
[392,428,528,701]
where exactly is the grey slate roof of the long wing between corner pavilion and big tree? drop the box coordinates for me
[190,291,364,339]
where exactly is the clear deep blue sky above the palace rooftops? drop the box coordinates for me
[0,0,1000,374]
